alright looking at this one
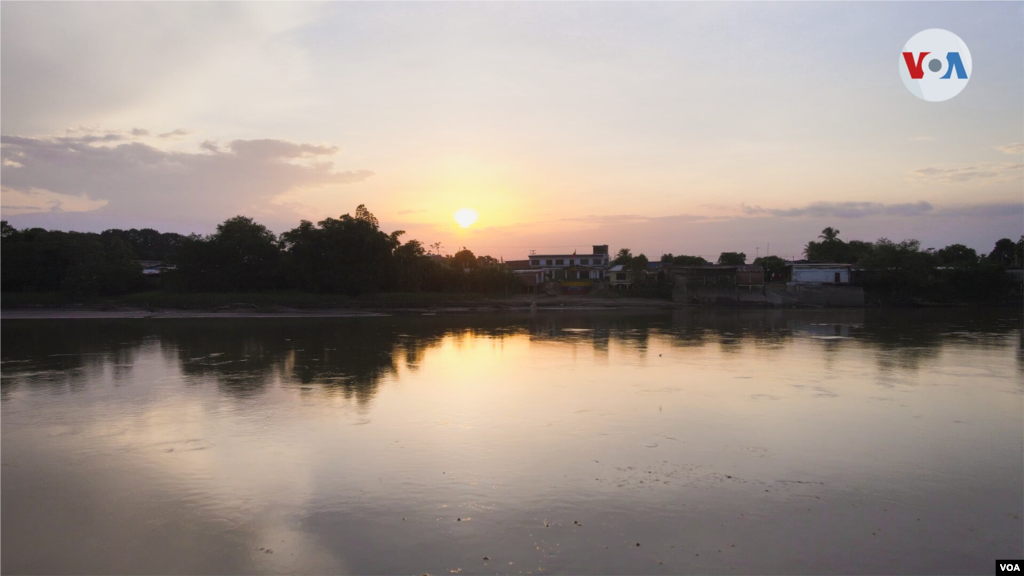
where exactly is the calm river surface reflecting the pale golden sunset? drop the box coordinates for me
[0,311,1024,576]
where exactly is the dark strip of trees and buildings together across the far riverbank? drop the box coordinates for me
[0,205,1024,306]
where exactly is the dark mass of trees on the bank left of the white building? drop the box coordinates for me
[0,205,519,296]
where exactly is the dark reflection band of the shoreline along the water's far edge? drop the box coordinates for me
[0,308,1024,404]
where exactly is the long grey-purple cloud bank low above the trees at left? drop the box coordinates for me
[0,133,373,229]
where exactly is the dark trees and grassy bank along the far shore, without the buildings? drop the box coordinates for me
[0,205,1024,311]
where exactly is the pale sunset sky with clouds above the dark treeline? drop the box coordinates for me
[0,0,1024,259]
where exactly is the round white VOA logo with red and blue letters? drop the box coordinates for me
[899,28,972,102]
